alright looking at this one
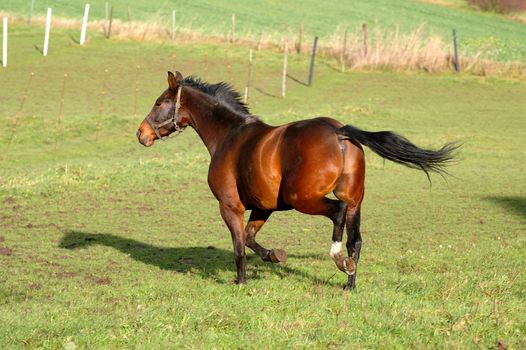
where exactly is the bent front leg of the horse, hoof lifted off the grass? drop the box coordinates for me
[245,209,287,263]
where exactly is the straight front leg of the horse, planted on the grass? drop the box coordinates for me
[219,203,250,284]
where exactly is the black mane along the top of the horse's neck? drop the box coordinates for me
[182,76,255,118]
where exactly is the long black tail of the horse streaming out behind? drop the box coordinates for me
[336,125,460,178]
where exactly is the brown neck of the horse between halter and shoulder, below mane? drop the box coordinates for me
[186,92,251,156]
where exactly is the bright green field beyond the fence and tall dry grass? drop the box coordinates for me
[0,0,526,63]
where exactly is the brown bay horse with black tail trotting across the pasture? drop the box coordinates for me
[137,71,459,290]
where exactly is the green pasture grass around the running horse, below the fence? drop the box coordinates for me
[0,23,526,349]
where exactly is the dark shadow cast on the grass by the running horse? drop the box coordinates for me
[59,231,337,286]
